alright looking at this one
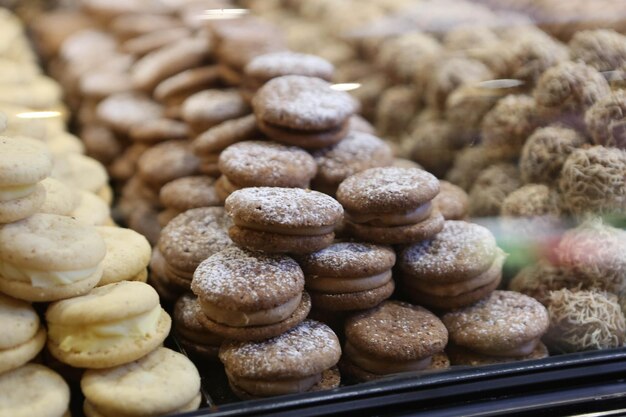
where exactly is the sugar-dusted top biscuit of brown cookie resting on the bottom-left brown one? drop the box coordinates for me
[191,246,304,311]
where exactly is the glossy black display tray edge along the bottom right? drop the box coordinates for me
[169,340,626,417]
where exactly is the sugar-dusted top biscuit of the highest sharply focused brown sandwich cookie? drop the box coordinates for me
[252,75,356,130]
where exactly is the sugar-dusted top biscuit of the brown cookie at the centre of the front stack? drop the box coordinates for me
[225,187,343,228]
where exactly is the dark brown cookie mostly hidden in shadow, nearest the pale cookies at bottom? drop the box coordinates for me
[174,294,224,360]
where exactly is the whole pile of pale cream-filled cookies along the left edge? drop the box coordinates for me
[0,10,201,417]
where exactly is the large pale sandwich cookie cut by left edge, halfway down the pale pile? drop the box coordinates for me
[0,213,106,301]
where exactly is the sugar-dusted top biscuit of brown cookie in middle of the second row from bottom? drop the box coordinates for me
[298,242,396,277]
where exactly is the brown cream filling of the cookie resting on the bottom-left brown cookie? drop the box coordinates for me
[199,294,302,327]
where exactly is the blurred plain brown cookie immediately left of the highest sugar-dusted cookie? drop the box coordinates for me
[182,90,250,134]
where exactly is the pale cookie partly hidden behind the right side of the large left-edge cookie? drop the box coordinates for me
[96,226,152,287]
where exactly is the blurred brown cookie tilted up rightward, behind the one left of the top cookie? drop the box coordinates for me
[153,65,220,107]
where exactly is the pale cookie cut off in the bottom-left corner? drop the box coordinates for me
[0,364,70,417]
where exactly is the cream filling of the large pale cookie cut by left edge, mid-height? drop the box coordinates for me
[0,260,102,288]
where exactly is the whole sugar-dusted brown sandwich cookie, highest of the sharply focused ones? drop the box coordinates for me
[252,75,356,149]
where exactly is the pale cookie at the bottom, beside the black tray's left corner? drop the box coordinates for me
[80,348,197,417]
